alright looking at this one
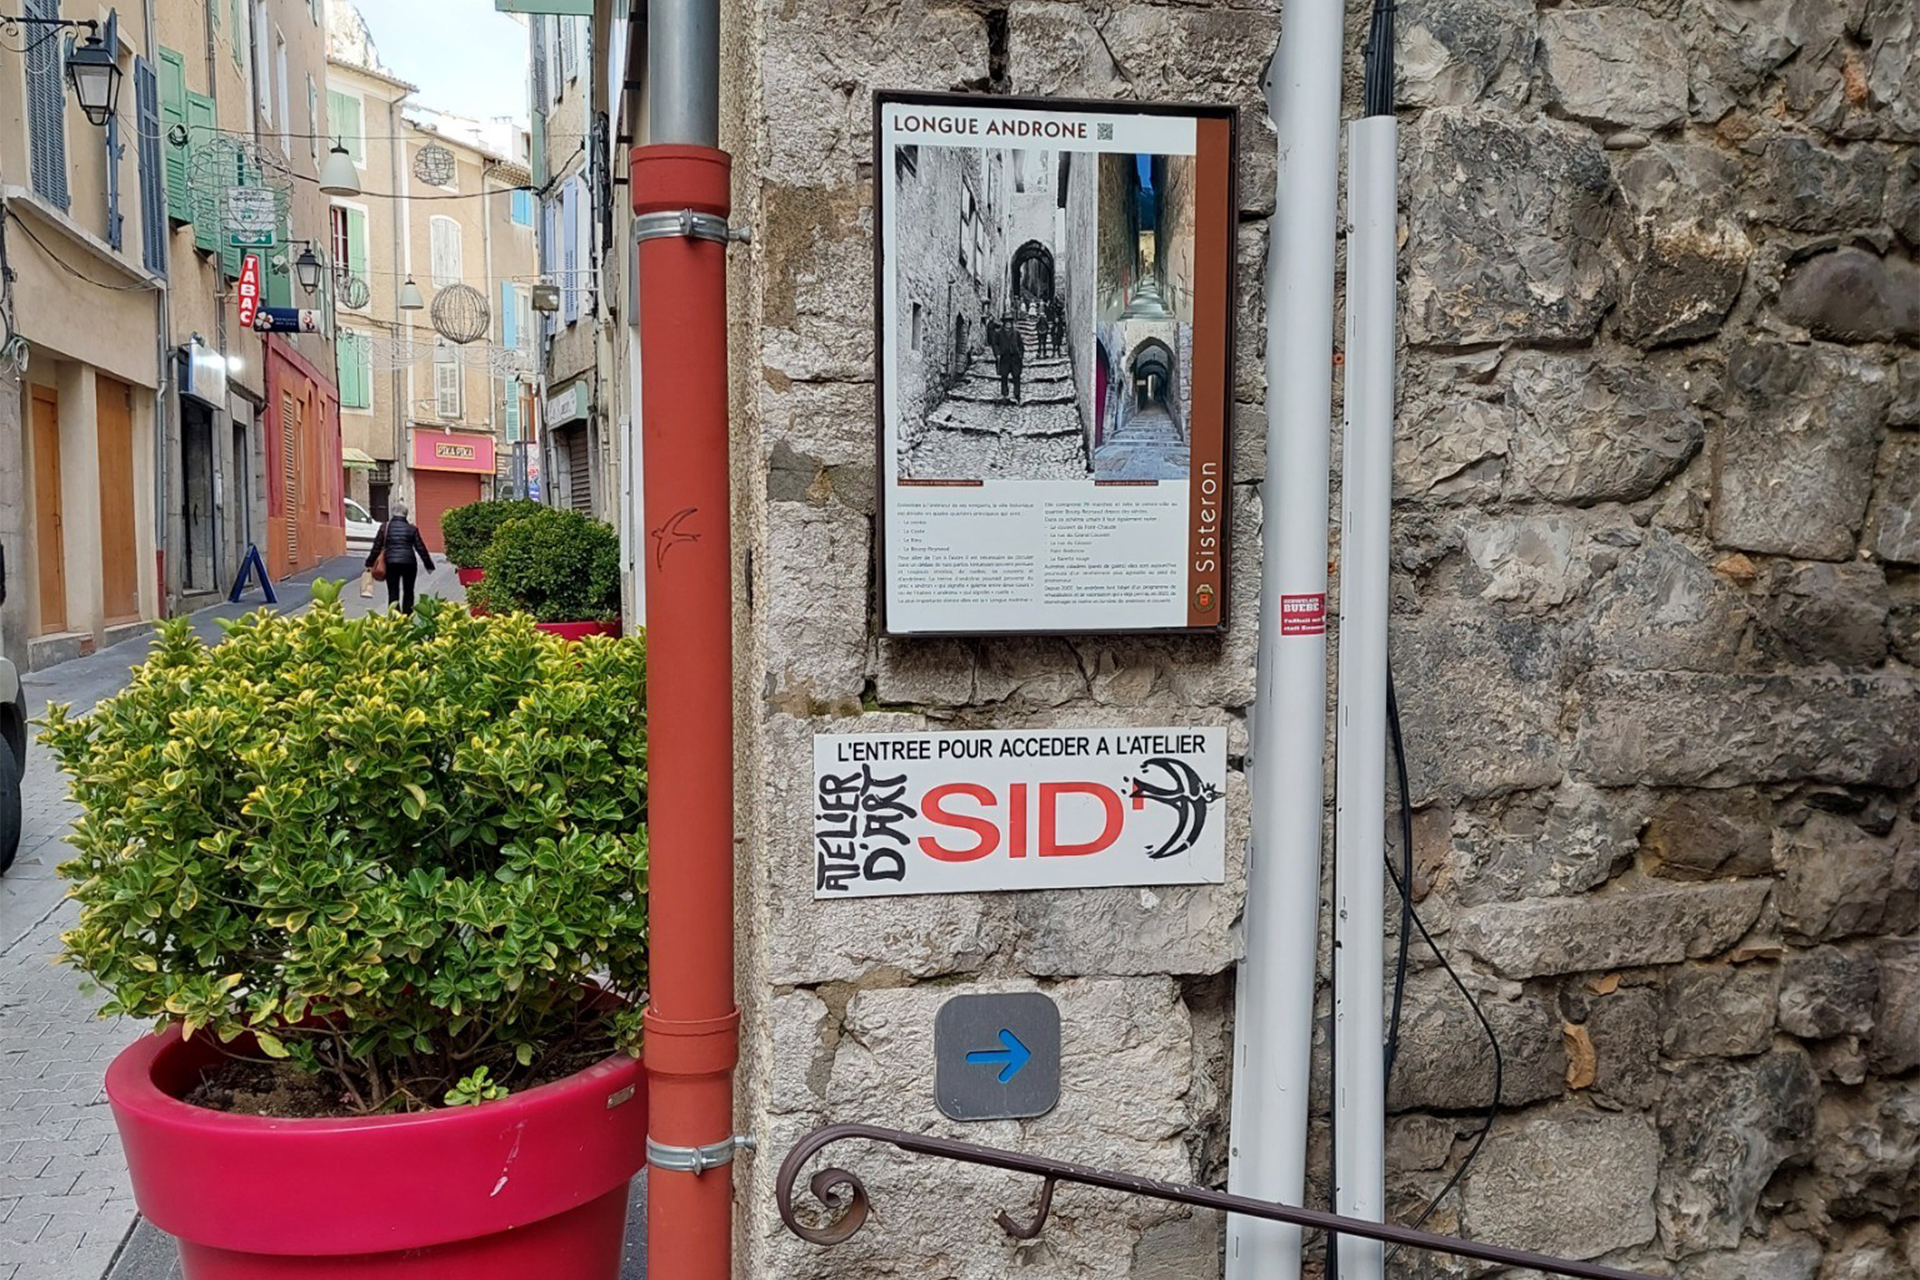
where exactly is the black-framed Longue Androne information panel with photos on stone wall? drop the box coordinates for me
[874,92,1238,635]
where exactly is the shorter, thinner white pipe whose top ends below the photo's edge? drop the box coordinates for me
[1332,115,1398,1280]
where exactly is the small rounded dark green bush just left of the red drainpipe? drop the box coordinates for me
[470,507,620,622]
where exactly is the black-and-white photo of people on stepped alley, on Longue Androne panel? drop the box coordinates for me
[891,144,1098,484]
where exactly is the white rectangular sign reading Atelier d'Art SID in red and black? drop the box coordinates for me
[814,729,1227,898]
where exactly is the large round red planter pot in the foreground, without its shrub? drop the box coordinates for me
[108,1029,647,1280]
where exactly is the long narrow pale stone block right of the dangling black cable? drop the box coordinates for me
[1453,881,1766,979]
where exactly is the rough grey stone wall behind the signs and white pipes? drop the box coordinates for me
[726,0,1920,1280]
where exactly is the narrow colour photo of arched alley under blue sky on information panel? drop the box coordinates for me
[1092,155,1194,480]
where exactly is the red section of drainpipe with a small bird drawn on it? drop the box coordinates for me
[630,144,739,1280]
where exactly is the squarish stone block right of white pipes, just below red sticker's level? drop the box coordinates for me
[1390,612,1565,804]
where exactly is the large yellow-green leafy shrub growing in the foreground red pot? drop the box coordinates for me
[40,583,647,1111]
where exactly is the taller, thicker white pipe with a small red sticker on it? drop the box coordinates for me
[1227,0,1344,1280]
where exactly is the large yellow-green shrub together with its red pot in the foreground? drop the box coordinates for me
[42,583,647,1280]
